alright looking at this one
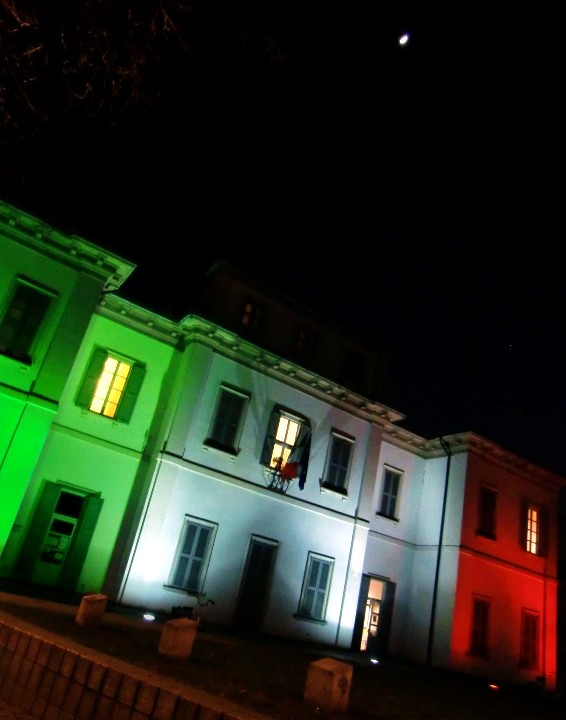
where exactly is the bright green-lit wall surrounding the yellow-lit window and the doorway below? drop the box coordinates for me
[0,306,177,593]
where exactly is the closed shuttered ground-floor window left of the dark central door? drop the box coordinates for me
[169,516,217,593]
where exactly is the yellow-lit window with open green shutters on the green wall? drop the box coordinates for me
[76,348,145,422]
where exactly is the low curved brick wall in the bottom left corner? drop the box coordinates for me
[0,614,269,720]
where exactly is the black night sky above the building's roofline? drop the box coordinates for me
[0,0,566,475]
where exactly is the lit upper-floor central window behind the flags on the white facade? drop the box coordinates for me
[260,406,311,490]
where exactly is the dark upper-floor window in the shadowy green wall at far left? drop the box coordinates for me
[0,278,54,365]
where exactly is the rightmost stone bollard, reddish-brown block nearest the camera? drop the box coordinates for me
[304,658,353,712]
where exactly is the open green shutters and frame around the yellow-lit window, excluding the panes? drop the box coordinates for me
[75,346,146,424]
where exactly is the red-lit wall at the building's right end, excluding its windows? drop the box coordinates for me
[451,454,558,688]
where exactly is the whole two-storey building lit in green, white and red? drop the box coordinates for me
[0,204,566,689]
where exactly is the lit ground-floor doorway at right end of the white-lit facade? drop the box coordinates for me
[352,575,395,656]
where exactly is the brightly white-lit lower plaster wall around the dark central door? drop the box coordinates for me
[120,462,364,644]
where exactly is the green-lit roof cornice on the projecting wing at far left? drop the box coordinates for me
[0,200,136,292]
